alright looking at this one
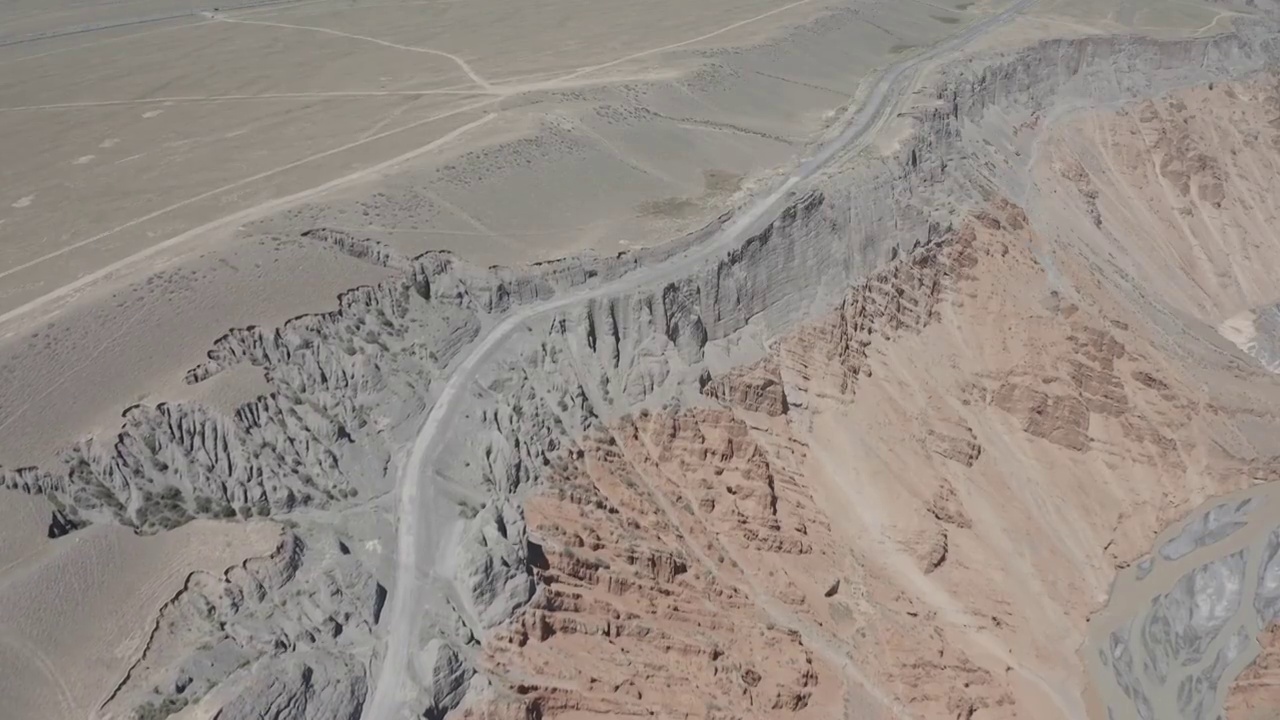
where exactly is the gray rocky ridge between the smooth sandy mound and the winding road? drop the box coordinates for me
[102,532,387,720]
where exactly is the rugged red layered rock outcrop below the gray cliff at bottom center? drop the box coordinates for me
[467,411,842,717]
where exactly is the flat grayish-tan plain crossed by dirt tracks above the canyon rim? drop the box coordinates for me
[0,0,1018,466]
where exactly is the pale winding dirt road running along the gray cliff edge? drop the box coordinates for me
[361,0,1037,720]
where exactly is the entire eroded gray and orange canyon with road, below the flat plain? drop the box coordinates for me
[0,3,1280,720]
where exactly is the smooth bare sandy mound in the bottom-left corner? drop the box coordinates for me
[0,492,279,717]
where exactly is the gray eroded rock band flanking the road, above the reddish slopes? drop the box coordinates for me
[3,19,1280,717]
